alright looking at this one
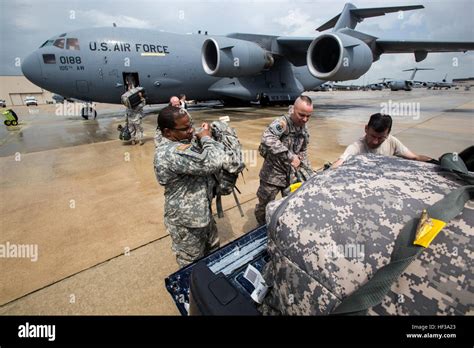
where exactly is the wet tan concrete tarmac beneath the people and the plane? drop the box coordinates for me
[0,89,474,315]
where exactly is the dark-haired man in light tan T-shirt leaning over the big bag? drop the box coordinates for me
[331,113,432,169]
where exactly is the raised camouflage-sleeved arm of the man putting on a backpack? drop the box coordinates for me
[170,136,226,176]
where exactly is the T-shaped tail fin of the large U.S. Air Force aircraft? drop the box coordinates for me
[316,3,424,31]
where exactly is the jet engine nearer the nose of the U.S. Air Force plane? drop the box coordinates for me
[201,37,274,77]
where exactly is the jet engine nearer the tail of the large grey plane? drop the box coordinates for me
[306,33,373,81]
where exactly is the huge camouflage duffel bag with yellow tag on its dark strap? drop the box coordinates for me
[260,155,474,315]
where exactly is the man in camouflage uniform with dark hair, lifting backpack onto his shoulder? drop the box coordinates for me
[154,106,225,267]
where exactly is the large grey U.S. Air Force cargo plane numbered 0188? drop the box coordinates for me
[22,3,474,115]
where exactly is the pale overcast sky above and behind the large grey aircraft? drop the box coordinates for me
[0,0,474,83]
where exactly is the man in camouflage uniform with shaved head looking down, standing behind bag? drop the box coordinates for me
[255,96,313,225]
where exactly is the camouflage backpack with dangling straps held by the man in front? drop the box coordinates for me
[211,121,245,217]
